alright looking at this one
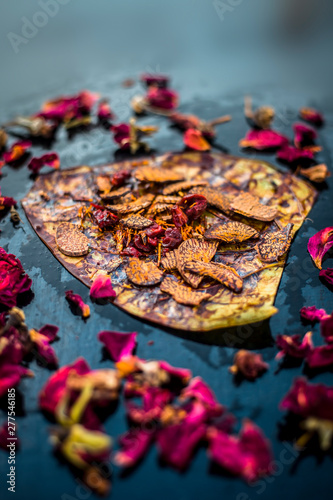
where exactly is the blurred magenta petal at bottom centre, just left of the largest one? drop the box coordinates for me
[156,421,206,470]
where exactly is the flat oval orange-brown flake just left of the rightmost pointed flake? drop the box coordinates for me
[204,222,259,243]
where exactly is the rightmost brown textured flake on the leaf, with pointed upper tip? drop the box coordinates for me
[256,223,293,262]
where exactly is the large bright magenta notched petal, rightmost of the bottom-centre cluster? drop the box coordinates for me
[208,420,273,482]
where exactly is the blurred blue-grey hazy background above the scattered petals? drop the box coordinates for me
[0,0,333,111]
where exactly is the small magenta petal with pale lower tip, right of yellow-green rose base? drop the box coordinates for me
[113,428,154,467]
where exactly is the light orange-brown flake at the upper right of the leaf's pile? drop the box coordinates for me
[230,192,277,222]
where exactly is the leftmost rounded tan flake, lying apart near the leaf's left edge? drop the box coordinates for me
[55,222,89,257]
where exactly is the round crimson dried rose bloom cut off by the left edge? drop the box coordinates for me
[0,247,32,307]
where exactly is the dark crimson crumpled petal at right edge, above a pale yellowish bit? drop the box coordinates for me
[280,377,333,420]
